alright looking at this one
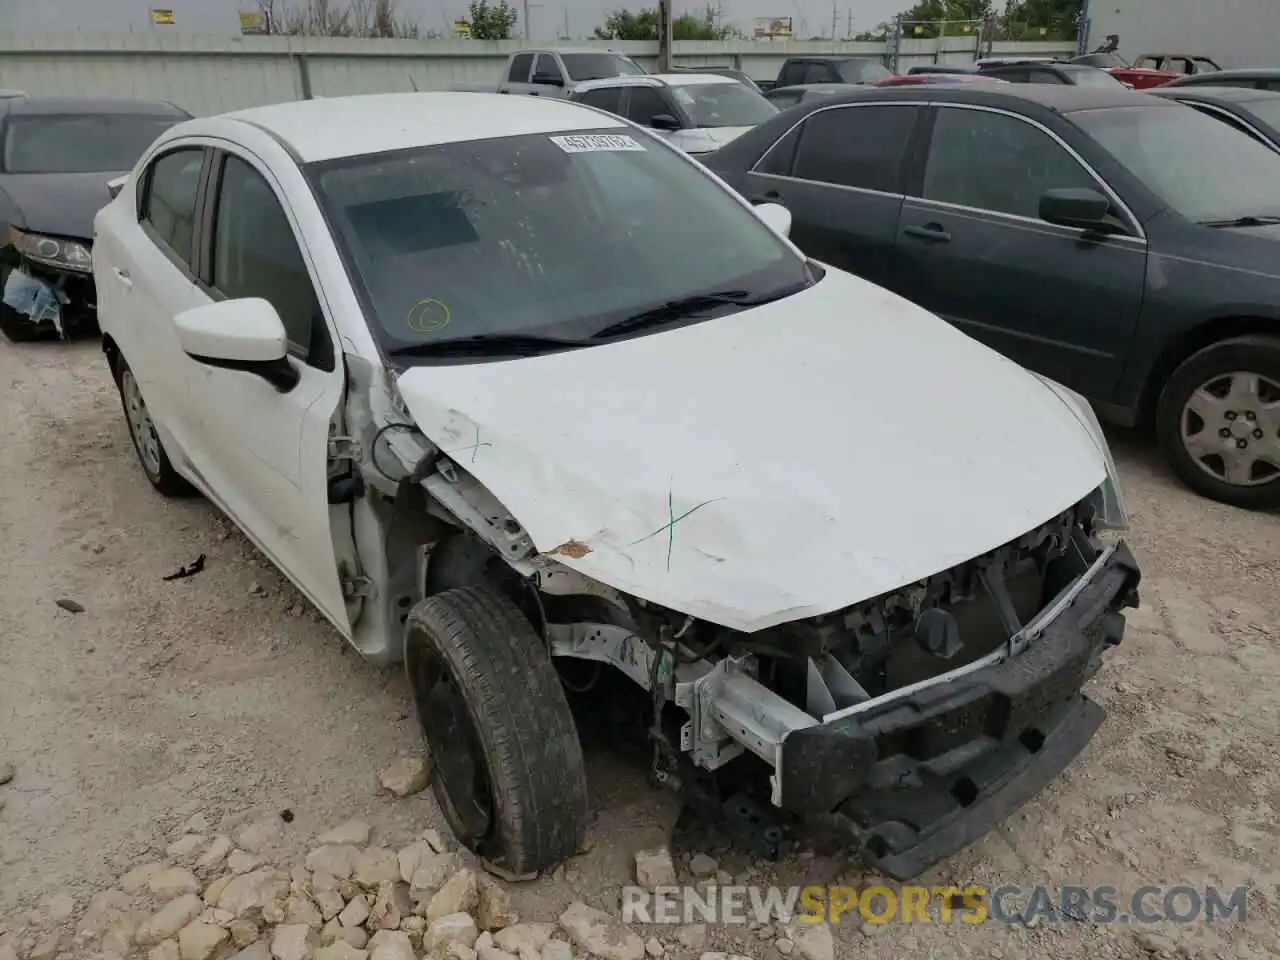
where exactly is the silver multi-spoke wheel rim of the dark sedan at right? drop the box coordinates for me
[1180,370,1280,486]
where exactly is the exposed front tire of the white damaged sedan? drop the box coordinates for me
[404,586,589,874]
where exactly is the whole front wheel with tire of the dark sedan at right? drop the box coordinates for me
[1156,337,1280,509]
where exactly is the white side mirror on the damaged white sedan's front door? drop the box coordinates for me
[173,297,301,393]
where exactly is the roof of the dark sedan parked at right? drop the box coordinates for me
[773,83,1179,114]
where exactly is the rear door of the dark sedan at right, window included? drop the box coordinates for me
[742,102,922,287]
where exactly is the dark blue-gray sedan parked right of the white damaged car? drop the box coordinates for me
[705,83,1280,508]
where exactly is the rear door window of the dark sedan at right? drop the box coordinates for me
[792,105,916,193]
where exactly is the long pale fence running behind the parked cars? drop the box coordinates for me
[0,32,1080,115]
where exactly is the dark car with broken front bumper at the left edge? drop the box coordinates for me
[0,95,189,340]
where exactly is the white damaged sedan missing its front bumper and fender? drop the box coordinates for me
[93,93,1139,879]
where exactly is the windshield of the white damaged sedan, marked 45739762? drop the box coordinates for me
[307,127,809,351]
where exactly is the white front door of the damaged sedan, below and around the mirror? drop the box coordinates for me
[182,150,349,635]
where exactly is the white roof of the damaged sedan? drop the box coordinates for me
[218,91,627,163]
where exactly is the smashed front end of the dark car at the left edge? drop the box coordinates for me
[0,228,97,339]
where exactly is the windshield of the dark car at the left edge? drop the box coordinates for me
[4,114,182,173]
